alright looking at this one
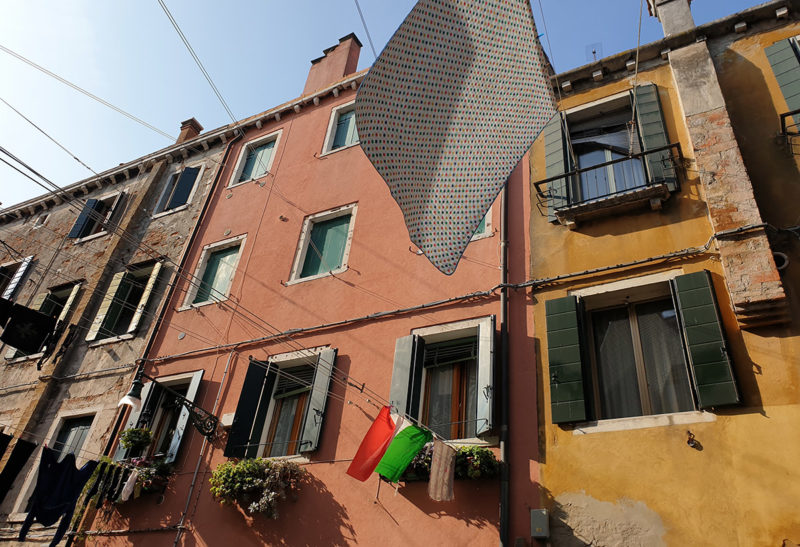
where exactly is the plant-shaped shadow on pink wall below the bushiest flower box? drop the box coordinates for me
[189,475,358,547]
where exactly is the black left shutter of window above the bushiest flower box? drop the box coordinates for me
[225,361,275,458]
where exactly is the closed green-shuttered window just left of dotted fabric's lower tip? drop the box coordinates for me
[290,205,356,281]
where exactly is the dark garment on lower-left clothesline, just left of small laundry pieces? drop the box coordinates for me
[19,446,97,547]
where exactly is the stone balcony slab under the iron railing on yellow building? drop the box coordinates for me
[556,183,670,230]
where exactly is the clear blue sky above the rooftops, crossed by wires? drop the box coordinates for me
[0,0,757,207]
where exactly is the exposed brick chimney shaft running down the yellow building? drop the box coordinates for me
[670,42,789,327]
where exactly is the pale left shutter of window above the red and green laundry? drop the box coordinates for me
[389,334,425,418]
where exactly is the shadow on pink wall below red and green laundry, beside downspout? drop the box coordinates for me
[398,479,500,530]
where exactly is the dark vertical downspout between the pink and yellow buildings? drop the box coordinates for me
[500,182,511,546]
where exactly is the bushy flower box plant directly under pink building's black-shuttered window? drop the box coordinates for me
[209,458,309,519]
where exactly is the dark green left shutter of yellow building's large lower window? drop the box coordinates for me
[545,296,586,424]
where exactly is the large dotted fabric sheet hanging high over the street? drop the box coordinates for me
[356,0,555,274]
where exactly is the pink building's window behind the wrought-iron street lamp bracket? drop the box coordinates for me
[114,370,203,463]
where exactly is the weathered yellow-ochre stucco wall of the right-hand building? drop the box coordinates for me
[531,17,800,546]
